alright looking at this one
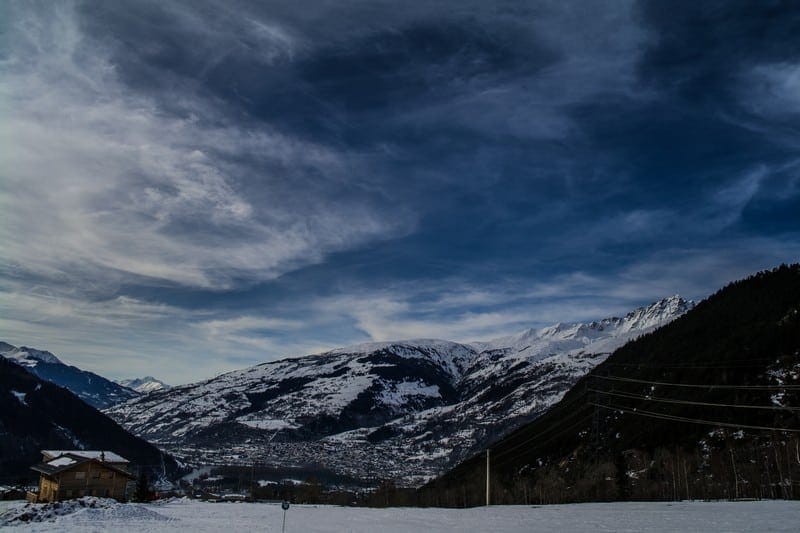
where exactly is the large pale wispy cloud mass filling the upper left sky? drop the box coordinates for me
[0,4,413,288]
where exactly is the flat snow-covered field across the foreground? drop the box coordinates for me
[0,500,800,533]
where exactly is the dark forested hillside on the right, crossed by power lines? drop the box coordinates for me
[420,265,800,506]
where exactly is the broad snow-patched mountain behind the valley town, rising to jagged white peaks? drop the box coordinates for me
[106,296,693,484]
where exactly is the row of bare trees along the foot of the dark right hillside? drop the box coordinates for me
[418,430,800,507]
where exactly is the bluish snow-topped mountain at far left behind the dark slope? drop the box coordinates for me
[0,342,139,409]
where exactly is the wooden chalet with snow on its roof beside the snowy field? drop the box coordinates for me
[28,450,135,502]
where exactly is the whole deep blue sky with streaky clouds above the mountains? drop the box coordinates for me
[0,0,800,384]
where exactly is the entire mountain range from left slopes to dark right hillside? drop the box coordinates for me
[0,265,800,500]
